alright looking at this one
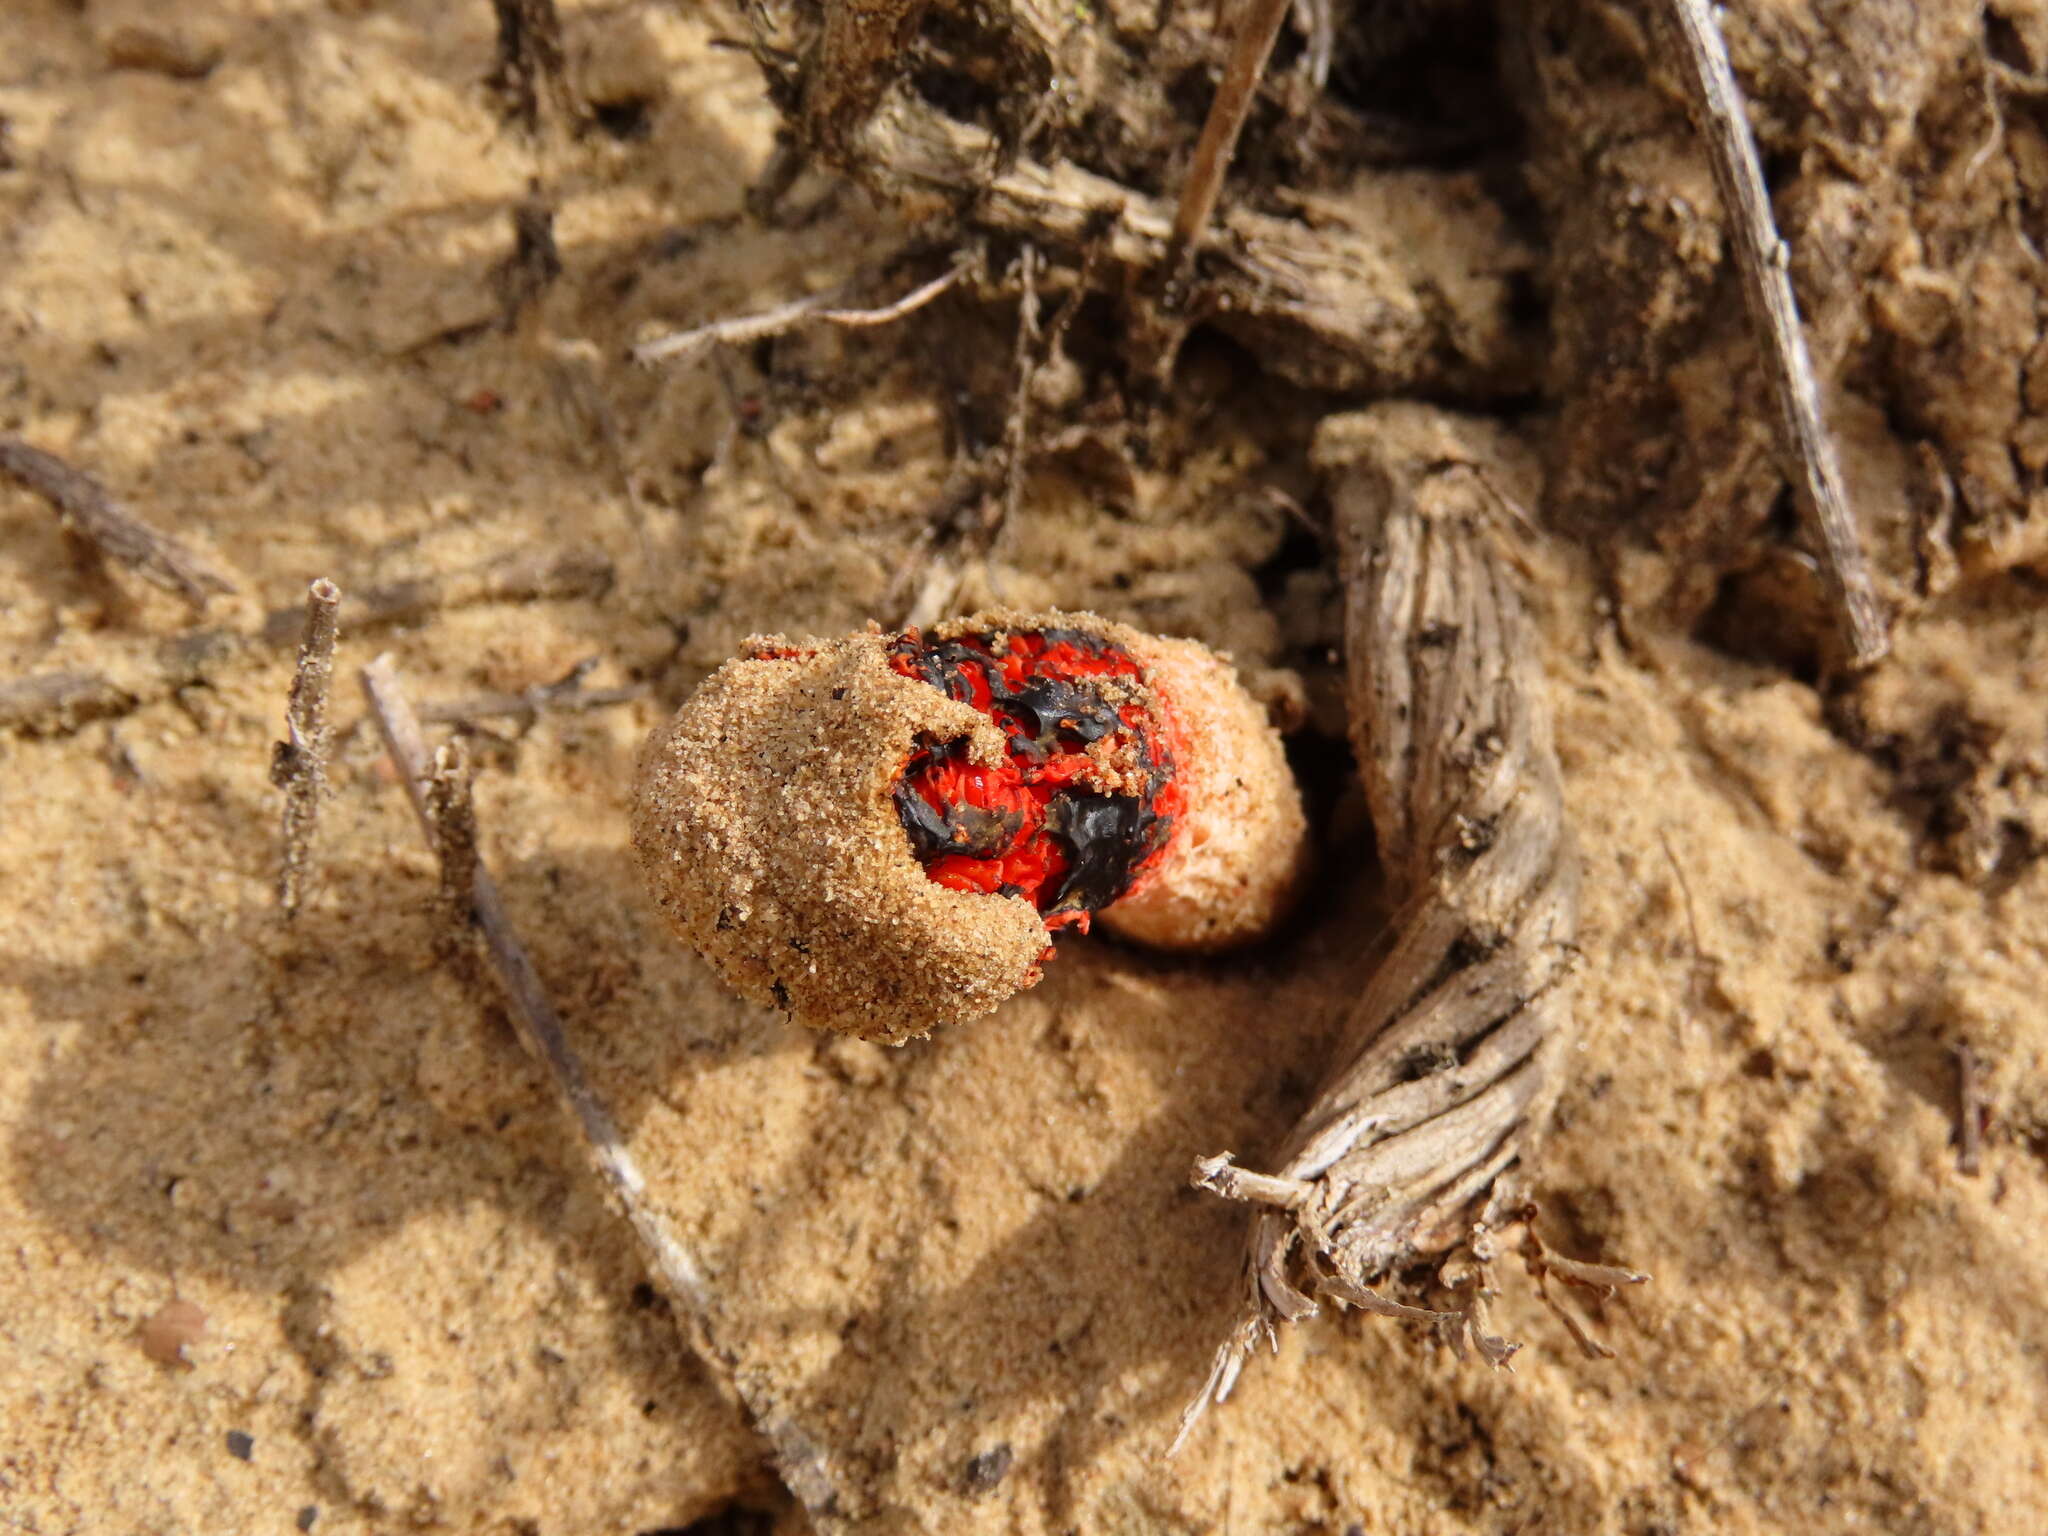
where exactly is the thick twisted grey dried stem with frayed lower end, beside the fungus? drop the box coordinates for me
[1176,406,1579,1444]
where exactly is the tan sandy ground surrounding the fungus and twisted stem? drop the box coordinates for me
[12,0,2048,1536]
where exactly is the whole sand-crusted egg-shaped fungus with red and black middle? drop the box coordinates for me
[633,612,1305,1040]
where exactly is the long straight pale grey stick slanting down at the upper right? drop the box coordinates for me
[1657,0,1890,666]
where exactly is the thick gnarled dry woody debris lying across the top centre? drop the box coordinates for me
[745,0,1534,395]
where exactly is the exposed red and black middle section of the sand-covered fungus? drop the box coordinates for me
[889,629,1184,932]
